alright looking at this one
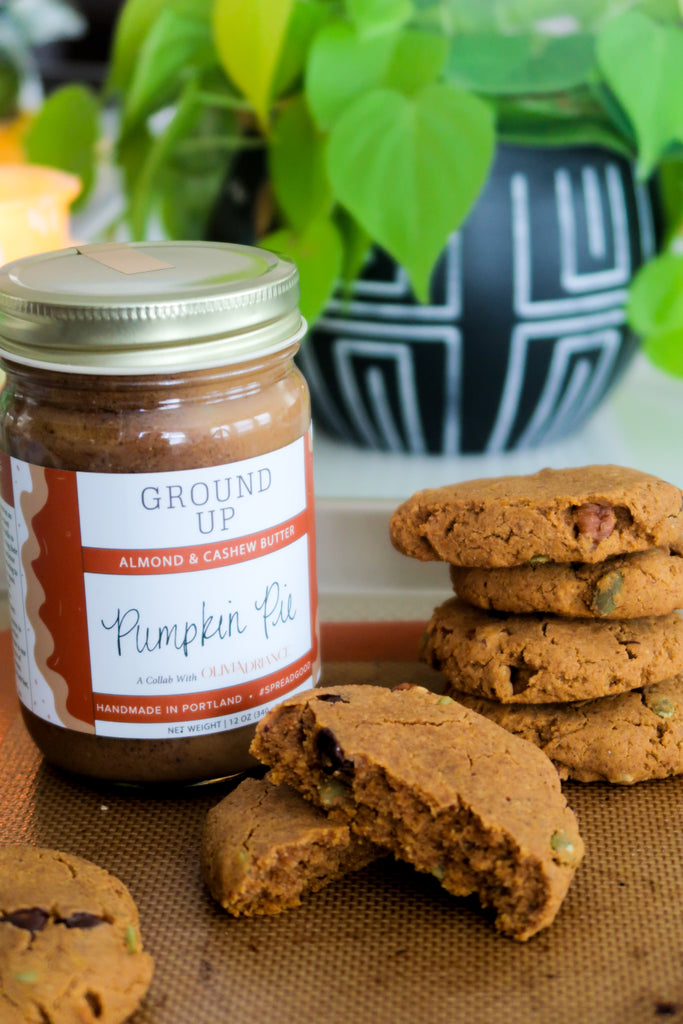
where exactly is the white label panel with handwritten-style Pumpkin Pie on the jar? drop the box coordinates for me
[85,537,312,696]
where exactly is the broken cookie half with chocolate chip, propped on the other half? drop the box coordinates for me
[251,684,584,940]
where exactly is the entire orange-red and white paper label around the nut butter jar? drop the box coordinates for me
[0,433,318,738]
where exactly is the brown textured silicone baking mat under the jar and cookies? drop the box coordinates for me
[0,624,683,1024]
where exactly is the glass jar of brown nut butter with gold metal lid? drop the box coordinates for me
[0,242,319,783]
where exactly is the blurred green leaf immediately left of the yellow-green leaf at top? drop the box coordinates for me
[118,8,215,130]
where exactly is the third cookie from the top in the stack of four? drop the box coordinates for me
[421,597,683,703]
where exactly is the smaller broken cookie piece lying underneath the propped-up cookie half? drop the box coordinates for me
[202,778,384,916]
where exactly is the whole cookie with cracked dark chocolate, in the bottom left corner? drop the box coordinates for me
[0,846,153,1024]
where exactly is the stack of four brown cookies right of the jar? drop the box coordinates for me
[390,466,683,784]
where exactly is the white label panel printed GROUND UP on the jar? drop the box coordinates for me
[78,438,306,548]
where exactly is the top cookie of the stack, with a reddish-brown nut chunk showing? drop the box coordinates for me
[389,466,683,568]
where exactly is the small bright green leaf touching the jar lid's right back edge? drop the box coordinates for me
[259,218,342,324]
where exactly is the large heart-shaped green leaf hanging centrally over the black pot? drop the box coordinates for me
[328,85,495,301]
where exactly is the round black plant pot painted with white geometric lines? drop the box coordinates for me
[298,145,655,455]
